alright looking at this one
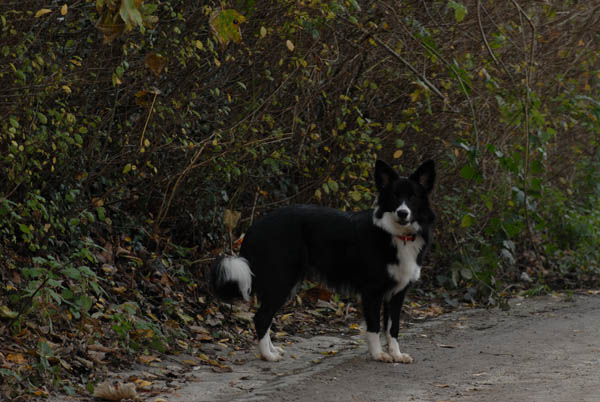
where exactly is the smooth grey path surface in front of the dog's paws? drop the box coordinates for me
[255,297,600,402]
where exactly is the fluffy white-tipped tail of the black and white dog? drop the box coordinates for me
[211,256,252,301]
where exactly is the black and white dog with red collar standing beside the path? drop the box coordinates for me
[211,160,435,363]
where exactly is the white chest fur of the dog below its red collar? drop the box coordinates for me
[385,236,425,300]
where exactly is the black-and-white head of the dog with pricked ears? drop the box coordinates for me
[373,160,435,236]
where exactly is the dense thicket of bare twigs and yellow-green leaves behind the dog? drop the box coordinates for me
[0,0,600,396]
